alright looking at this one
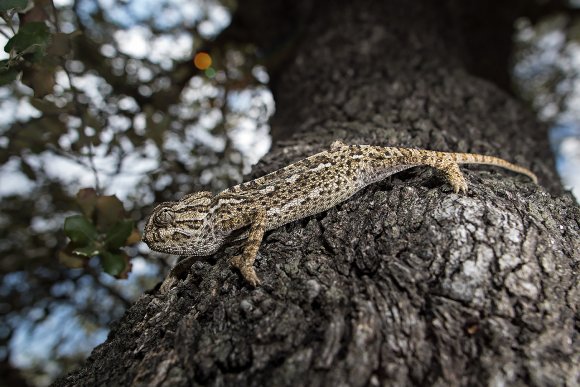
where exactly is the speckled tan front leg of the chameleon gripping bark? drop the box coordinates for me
[231,208,266,286]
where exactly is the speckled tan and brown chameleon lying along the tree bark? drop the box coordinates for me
[143,141,538,286]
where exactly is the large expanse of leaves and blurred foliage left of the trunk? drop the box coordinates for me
[0,0,273,385]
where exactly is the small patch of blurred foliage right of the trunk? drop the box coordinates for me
[513,0,580,201]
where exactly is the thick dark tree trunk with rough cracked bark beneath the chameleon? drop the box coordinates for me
[56,0,580,386]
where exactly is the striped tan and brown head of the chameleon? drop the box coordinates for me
[143,192,223,255]
